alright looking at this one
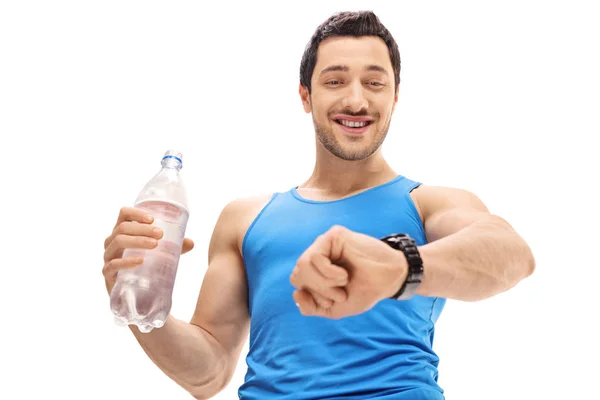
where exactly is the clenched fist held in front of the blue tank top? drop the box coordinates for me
[290,226,407,319]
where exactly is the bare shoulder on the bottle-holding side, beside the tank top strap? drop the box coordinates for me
[213,193,274,254]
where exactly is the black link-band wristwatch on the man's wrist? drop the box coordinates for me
[381,233,423,300]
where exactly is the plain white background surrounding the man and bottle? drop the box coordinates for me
[0,0,600,400]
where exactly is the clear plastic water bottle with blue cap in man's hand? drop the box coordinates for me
[110,150,189,333]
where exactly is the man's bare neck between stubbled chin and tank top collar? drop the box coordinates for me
[299,148,396,198]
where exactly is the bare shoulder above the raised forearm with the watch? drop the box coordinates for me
[410,185,488,219]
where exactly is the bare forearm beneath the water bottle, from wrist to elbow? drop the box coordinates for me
[130,316,230,399]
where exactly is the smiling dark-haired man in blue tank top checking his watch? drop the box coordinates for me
[103,12,534,400]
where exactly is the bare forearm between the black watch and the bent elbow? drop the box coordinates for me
[417,216,535,301]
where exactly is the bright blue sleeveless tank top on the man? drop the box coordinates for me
[238,176,445,400]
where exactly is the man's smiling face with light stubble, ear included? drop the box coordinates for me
[300,36,398,161]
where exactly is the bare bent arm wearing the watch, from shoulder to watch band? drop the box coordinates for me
[412,186,535,301]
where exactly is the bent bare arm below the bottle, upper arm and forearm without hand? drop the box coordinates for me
[132,201,254,399]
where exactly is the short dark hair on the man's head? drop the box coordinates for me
[300,11,400,93]
